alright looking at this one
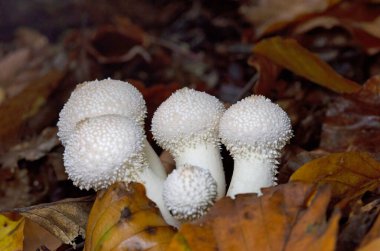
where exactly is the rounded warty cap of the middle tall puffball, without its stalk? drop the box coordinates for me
[152,88,225,155]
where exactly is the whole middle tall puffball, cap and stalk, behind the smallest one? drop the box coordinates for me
[152,88,226,198]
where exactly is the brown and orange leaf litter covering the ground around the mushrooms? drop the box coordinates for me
[0,0,380,250]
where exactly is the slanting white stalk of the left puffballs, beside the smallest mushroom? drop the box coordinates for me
[139,168,179,228]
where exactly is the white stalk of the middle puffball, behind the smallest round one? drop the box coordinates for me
[175,142,226,199]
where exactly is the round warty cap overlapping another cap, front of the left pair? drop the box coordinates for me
[63,115,145,190]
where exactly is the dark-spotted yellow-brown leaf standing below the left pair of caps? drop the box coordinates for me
[85,183,175,251]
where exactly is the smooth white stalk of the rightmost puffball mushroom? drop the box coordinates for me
[227,156,277,198]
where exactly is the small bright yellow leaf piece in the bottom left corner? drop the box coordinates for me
[0,214,25,251]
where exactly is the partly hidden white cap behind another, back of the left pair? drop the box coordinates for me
[57,78,146,145]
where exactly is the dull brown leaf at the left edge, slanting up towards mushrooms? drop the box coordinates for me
[0,70,63,151]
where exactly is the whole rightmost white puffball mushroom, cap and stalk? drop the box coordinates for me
[219,95,293,197]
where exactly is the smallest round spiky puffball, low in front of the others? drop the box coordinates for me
[163,165,217,221]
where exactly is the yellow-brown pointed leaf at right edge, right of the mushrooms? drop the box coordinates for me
[290,152,380,201]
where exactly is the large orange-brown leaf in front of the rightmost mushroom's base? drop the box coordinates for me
[168,182,340,251]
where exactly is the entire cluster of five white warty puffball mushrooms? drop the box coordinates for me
[57,79,293,226]
